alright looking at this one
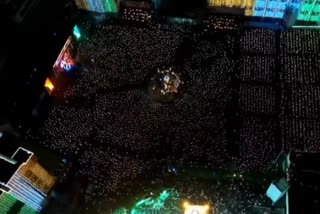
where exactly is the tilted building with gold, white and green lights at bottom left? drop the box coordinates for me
[0,147,55,214]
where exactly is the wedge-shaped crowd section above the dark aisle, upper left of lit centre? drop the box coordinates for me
[68,24,183,96]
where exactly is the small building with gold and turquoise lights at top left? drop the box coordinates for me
[75,0,118,13]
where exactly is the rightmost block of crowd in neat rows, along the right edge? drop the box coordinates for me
[280,29,320,151]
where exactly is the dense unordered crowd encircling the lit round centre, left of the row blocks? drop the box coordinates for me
[37,20,233,197]
